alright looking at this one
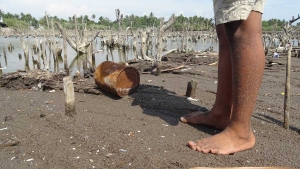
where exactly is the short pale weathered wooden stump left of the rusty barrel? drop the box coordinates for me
[63,76,76,116]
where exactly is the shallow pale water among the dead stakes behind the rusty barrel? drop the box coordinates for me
[0,37,217,74]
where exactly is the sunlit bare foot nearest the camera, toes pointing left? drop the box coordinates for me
[188,127,255,155]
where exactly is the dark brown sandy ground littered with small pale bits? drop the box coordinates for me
[0,53,300,169]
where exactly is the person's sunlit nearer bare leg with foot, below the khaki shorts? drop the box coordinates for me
[181,11,265,154]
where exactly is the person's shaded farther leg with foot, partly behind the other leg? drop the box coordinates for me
[180,24,232,129]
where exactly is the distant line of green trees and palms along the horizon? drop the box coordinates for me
[0,11,300,31]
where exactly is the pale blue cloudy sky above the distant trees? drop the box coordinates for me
[0,0,300,23]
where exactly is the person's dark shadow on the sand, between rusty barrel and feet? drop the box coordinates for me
[126,85,220,135]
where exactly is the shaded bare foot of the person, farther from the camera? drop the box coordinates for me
[180,111,230,129]
